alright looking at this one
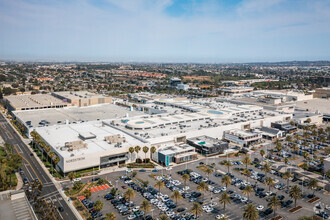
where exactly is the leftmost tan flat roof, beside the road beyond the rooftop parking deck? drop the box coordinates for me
[5,94,67,109]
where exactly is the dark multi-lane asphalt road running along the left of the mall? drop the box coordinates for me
[0,113,77,220]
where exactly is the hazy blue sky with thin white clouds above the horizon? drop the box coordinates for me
[0,0,330,63]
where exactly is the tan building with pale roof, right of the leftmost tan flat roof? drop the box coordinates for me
[52,91,112,107]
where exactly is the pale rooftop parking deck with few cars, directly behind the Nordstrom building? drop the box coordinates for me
[13,104,144,127]
